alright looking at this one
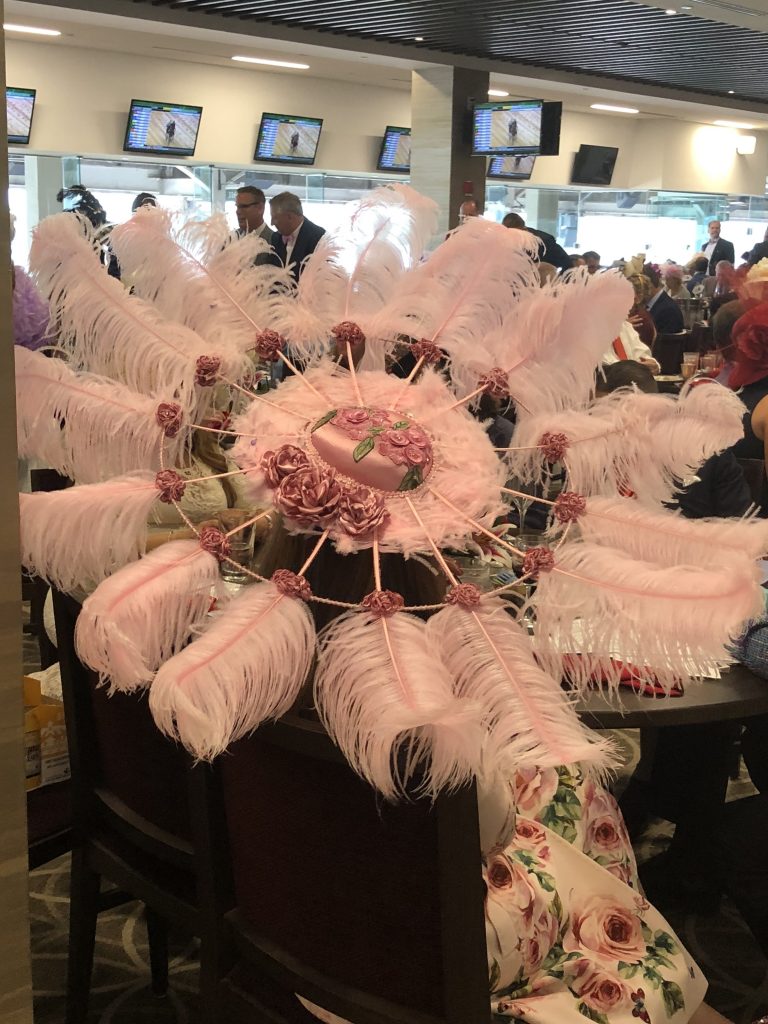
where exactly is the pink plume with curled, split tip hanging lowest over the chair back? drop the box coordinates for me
[314,611,482,800]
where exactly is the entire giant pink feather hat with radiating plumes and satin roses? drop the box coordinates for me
[17,186,768,798]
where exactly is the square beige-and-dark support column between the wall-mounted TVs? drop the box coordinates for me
[411,67,488,239]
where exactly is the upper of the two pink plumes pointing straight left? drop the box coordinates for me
[16,349,182,483]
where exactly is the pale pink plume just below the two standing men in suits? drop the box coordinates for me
[111,207,293,353]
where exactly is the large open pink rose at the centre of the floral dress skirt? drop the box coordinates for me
[564,895,645,964]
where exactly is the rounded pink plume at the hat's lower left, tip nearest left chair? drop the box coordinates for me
[75,541,219,691]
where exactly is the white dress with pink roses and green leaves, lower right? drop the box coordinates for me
[483,767,707,1024]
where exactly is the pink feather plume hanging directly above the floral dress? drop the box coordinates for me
[427,598,611,772]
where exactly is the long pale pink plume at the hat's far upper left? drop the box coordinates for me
[30,213,248,416]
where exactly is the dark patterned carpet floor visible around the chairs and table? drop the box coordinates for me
[25,610,768,1024]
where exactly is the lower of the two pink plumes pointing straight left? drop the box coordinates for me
[18,473,158,591]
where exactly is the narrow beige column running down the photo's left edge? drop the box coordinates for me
[0,9,32,1024]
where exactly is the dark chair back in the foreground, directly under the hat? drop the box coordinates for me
[198,717,489,1024]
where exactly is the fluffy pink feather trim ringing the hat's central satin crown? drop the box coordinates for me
[233,364,505,555]
